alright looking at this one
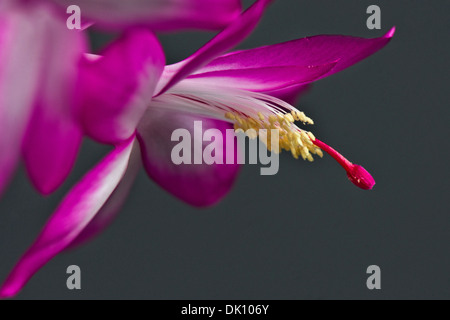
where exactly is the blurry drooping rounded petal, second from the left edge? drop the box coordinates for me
[23,13,86,194]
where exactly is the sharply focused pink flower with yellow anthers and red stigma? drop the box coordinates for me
[0,0,394,297]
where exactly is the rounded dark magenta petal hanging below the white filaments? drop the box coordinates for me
[138,108,239,207]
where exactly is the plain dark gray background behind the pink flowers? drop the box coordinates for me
[0,0,450,299]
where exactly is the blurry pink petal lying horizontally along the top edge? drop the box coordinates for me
[49,0,241,30]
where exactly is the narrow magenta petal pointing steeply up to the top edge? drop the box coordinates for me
[157,0,272,95]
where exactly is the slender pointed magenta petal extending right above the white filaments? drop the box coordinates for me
[183,62,336,92]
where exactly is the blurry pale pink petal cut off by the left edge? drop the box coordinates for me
[0,6,46,194]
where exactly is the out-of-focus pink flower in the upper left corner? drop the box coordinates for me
[0,0,240,194]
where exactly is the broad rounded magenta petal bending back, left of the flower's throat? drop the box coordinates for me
[80,29,165,144]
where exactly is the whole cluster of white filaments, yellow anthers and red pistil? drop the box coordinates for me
[158,83,375,190]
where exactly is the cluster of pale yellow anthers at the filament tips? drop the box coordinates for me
[225,111,323,162]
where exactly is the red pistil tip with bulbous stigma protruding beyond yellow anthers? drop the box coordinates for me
[314,139,375,190]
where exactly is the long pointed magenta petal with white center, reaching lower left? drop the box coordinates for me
[0,139,134,298]
